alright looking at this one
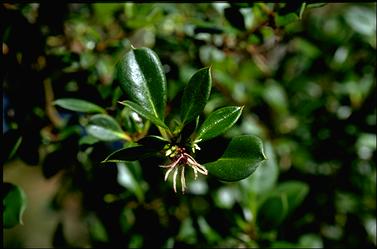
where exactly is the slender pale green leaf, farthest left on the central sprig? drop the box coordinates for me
[54,98,106,113]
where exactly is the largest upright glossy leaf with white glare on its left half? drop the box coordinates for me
[117,48,167,120]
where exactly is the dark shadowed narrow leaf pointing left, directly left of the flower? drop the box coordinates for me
[102,145,158,163]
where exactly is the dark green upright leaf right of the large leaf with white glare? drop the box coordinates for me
[180,67,212,125]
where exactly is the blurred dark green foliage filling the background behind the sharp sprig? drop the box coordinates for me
[0,2,376,248]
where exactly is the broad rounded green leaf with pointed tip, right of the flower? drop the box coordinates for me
[204,135,266,181]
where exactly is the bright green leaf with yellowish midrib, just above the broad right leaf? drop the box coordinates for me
[196,106,243,140]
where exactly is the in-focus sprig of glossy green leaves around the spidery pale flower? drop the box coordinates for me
[108,48,266,186]
